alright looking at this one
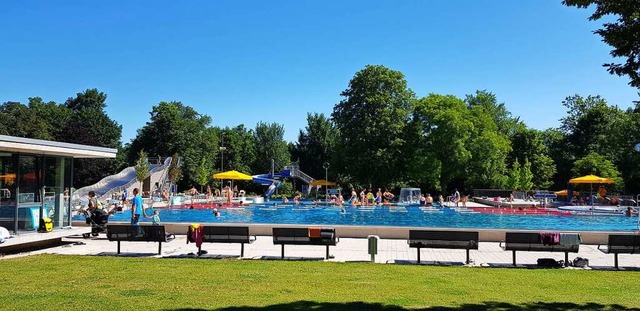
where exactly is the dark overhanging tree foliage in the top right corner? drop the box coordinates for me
[562,0,640,88]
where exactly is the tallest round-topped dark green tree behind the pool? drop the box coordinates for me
[331,65,415,185]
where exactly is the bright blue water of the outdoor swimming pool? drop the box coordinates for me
[76,205,638,231]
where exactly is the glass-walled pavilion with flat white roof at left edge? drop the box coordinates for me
[0,135,117,232]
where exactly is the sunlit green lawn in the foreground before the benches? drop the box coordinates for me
[0,255,640,311]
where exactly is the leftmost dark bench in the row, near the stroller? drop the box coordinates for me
[107,225,173,255]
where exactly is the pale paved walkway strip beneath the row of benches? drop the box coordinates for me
[4,235,640,270]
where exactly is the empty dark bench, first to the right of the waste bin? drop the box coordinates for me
[407,230,478,264]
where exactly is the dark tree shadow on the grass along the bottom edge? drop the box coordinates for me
[169,301,640,311]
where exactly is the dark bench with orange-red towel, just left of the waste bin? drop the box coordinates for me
[273,228,340,259]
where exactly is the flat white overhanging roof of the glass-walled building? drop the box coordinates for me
[0,135,118,159]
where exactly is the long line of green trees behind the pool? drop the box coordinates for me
[0,65,640,194]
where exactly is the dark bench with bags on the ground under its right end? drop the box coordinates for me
[500,232,580,266]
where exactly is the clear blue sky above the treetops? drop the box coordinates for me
[0,0,638,142]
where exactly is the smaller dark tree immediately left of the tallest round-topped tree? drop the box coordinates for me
[291,113,337,178]
